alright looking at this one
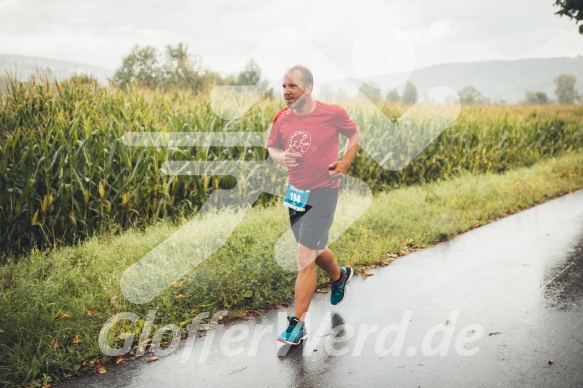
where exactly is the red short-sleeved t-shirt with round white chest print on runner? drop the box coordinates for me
[267,101,358,190]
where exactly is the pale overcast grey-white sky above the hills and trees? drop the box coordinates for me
[0,0,583,83]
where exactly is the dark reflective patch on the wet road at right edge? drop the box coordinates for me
[543,231,583,309]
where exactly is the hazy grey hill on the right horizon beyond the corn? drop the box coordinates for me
[409,55,583,103]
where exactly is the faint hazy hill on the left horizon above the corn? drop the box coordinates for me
[0,54,113,84]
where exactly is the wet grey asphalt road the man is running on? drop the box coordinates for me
[60,190,583,387]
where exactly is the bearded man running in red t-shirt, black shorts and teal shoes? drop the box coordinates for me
[267,65,361,345]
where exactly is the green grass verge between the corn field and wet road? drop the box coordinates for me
[0,152,583,384]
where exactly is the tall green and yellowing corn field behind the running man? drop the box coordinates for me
[0,77,583,260]
